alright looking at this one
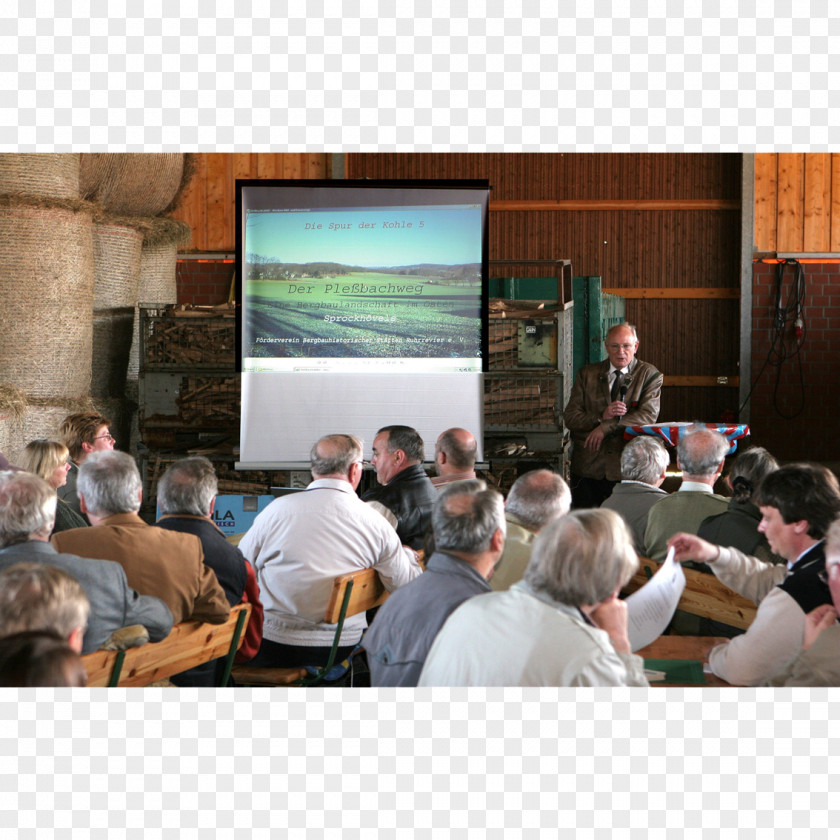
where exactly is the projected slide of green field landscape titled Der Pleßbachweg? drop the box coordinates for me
[243,205,482,363]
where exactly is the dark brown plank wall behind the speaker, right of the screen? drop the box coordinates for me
[346,153,741,421]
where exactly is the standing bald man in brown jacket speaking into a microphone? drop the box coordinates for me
[563,323,662,508]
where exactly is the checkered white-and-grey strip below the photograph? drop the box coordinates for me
[0,688,840,840]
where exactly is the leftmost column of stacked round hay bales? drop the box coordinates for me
[0,154,94,462]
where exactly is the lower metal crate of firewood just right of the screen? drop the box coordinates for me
[484,372,563,432]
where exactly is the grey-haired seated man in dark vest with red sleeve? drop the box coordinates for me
[156,455,263,686]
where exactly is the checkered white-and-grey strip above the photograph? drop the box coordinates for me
[0,0,840,151]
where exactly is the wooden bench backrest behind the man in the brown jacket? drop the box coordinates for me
[82,604,251,687]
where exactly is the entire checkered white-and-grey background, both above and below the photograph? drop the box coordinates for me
[0,0,840,840]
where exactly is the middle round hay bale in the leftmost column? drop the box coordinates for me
[0,203,94,398]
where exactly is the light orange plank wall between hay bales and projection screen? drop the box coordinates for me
[172,152,332,252]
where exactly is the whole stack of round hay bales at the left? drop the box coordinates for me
[0,154,193,463]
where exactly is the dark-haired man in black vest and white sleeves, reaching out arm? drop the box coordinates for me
[669,464,840,685]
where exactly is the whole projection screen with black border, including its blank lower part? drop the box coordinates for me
[236,180,489,469]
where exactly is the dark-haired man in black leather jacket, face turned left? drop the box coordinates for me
[362,426,437,551]
